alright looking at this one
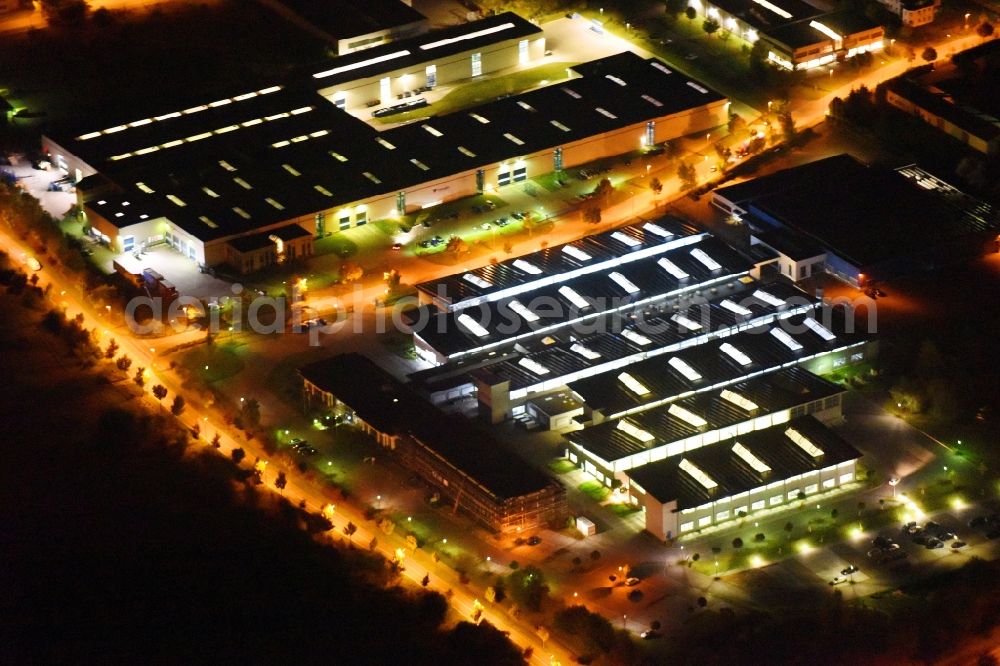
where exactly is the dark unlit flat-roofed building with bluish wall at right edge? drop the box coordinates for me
[712,155,1000,285]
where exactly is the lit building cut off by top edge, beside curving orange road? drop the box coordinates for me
[688,0,885,69]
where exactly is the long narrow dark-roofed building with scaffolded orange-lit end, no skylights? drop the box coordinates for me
[299,354,568,534]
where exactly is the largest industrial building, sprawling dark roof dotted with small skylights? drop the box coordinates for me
[43,13,728,271]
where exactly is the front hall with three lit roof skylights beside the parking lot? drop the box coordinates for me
[628,416,861,539]
